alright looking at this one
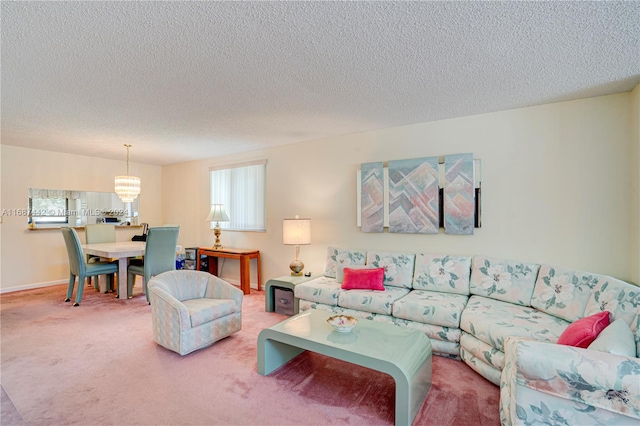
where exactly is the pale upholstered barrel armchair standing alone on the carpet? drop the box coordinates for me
[149,270,244,355]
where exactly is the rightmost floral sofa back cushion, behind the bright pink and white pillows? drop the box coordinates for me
[584,275,640,334]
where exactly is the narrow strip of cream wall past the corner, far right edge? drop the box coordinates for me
[629,85,640,284]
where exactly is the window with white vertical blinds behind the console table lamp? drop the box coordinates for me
[209,160,267,231]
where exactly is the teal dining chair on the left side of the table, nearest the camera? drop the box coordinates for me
[61,226,118,306]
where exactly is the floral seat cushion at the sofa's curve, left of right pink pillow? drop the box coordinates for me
[460,295,569,352]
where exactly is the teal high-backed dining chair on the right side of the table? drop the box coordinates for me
[127,226,180,302]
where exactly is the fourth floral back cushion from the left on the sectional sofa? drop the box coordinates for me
[470,256,540,306]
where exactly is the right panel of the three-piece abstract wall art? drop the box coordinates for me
[444,153,475,235]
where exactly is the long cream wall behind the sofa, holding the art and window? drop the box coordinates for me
[162,93,638,284]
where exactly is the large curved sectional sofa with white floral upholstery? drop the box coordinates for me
[294,247,640,425]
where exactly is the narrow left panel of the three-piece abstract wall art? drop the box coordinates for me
[360,162,385,232]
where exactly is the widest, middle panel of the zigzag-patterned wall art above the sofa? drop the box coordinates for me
[389,157,440,234]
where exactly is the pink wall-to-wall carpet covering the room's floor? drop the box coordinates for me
[0,285,500,426]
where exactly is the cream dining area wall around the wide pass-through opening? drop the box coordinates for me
[0,145,162,291]
